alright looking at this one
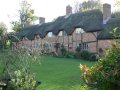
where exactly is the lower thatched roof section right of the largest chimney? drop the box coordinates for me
[98,18,120,40]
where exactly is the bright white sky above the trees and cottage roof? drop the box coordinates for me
[0,0,114,29]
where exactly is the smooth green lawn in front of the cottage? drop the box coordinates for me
[32,56,95,90]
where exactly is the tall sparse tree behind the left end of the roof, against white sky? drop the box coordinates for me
[11,0,38,31]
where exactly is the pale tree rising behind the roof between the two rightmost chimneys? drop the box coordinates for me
[75,0,102,13]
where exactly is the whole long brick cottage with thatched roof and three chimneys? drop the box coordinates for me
[14,4,120,53]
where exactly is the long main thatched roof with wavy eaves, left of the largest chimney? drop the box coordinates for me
[15,10,103,40]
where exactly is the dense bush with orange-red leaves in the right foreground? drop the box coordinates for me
[80,29,120,90]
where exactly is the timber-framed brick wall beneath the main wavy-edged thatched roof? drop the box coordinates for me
[14,32,99,52]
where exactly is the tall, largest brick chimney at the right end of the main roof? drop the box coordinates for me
[103,4,111,20]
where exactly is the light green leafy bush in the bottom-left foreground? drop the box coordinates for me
[8,69,37,90]
